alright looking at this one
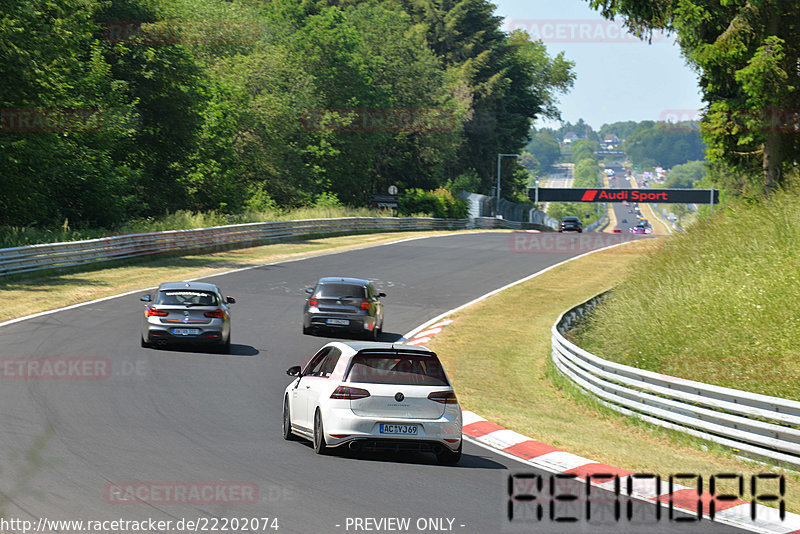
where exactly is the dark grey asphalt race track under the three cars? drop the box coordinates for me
[0,233,748,534]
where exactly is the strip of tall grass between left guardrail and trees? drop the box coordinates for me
[0,206,389,248]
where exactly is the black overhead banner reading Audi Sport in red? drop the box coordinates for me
[528,187,719,204]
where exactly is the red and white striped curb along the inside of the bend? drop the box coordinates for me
[405,319,800,534]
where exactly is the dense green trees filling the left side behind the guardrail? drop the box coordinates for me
[0,0,574,226]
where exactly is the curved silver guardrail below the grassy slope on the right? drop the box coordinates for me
[552,294,800,469]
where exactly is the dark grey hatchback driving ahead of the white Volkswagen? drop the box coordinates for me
[303,277,386,340]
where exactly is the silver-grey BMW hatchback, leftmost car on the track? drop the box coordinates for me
[140,282,236,354]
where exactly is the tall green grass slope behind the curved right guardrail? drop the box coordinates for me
[577,187,800,400]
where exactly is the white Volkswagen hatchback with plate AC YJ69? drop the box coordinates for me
[283,341,462,465]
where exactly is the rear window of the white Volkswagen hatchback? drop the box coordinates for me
[347,353,450,386]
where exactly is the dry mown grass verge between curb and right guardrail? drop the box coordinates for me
[429,238,800,512]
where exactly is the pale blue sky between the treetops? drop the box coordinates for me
[492,0,703,130]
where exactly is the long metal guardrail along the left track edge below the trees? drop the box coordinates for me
[0,217,469,277]
